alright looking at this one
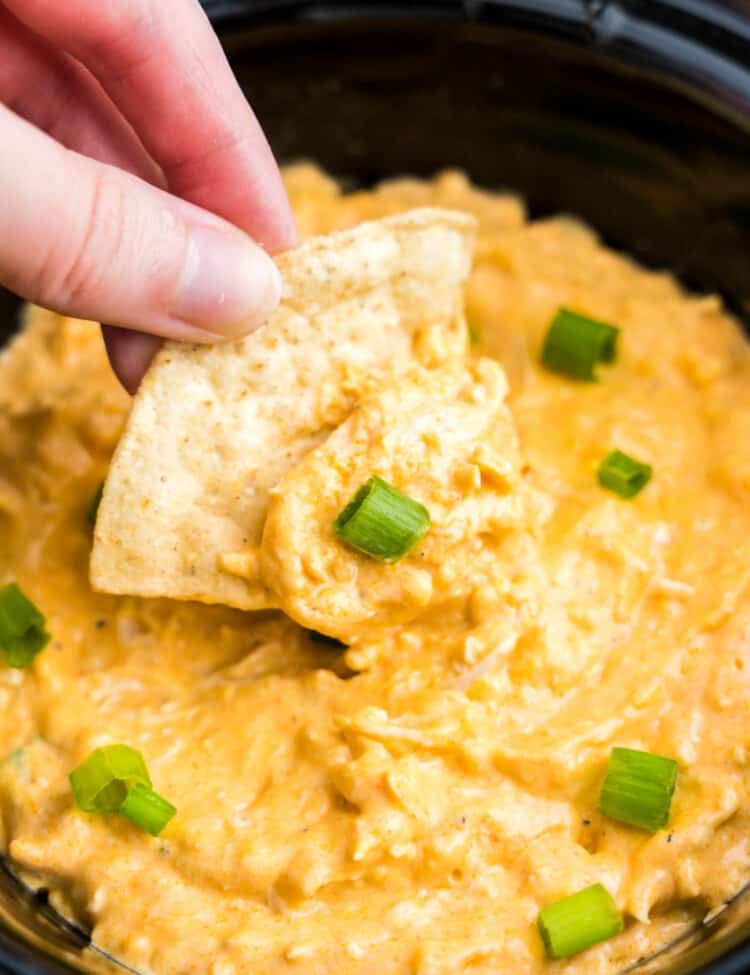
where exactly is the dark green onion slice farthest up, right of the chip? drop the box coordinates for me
[541,308,620,382]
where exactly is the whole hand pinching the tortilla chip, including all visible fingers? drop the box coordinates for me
[0,0,295,391]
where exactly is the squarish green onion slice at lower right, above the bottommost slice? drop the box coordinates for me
[599,748,677,833]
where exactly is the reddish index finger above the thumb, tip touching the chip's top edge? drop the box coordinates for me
[4,0,296,251]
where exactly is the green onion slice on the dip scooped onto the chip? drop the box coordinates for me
[333,477,430,562]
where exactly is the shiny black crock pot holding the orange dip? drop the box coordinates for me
[0,0,750,975]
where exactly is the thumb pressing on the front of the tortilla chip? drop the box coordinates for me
[0,105,281,342]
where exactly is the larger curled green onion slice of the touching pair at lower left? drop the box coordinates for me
[68,745,151,812]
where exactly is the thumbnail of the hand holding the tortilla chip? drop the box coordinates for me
[170,227,281,338]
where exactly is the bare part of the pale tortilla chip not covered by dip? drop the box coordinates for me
[91,209,475,609]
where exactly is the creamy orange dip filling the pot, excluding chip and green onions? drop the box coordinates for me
[0,166,750,975]
